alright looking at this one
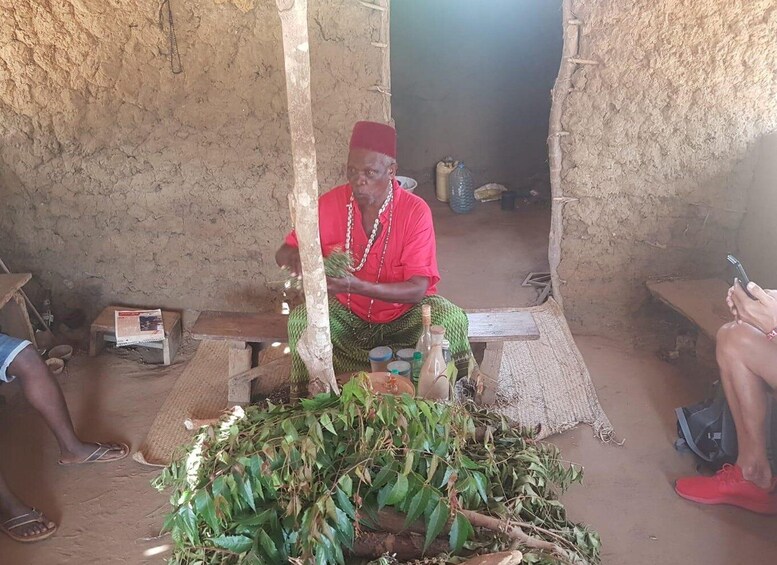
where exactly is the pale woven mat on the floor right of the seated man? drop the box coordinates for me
[495,298,614,442]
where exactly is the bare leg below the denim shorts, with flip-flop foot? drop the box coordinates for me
[8,346,123,463]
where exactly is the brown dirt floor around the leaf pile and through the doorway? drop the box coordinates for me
[0,200,777,565]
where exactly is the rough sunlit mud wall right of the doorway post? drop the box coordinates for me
[558,0,777,333]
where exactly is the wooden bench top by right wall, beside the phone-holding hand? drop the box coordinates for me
[647,279,733,340]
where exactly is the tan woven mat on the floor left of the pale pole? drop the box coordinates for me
[132,341,229,467]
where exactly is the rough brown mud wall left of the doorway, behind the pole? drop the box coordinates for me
[0,0,383,320]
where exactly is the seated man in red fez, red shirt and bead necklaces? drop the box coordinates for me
[275,122,475,396]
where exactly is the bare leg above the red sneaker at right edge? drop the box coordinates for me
[716,323,777,488]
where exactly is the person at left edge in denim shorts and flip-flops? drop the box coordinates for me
[0,333,129,542]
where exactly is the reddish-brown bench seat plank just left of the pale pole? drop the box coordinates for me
[191,311,289,343]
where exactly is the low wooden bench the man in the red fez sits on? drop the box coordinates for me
[191,308,540,406]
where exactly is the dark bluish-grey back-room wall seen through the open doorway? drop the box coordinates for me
[391,0,561,192]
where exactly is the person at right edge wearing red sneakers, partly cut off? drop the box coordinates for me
[675,282,777,514]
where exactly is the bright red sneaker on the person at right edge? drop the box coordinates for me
[674,465,777,514]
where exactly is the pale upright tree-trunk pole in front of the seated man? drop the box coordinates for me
[276,0,340,397]
